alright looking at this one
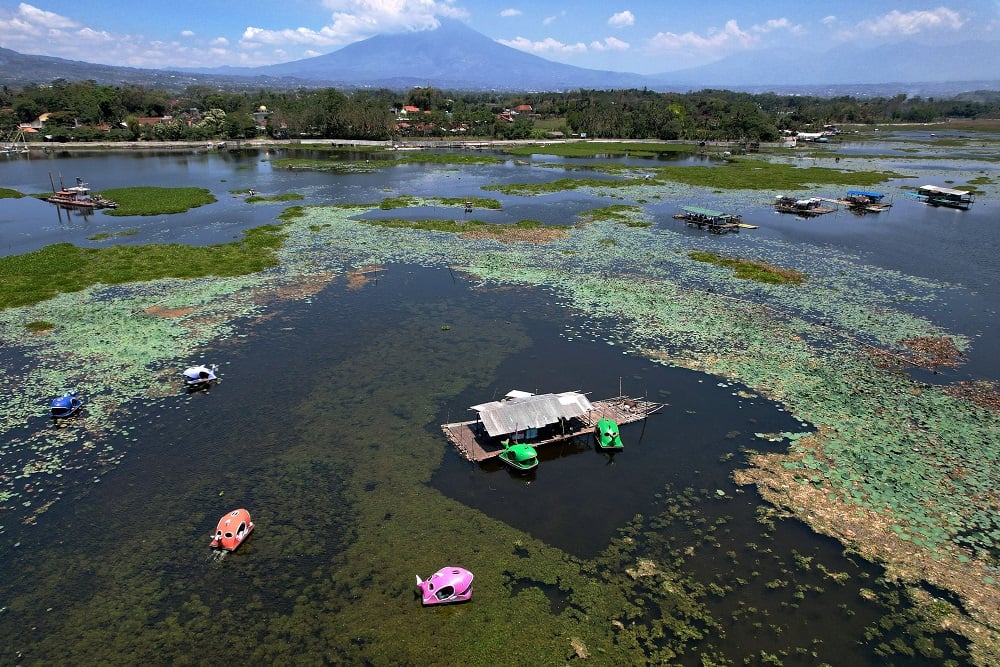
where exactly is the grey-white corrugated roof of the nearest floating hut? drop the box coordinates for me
[469,391,594,437]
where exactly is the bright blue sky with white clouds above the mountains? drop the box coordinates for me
[0,0,1000,74]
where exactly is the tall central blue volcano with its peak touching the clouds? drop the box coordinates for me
[187,19,652,91]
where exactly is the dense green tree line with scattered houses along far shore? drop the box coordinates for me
[0,79,1000,142]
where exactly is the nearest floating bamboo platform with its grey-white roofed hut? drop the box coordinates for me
[441,392,665,462]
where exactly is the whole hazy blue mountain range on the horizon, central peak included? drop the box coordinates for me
[0,20,1000,97]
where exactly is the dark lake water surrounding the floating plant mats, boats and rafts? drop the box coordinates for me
[0,138,1000,665]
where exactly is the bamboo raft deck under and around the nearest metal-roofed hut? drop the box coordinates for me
[441,396,665,463]
